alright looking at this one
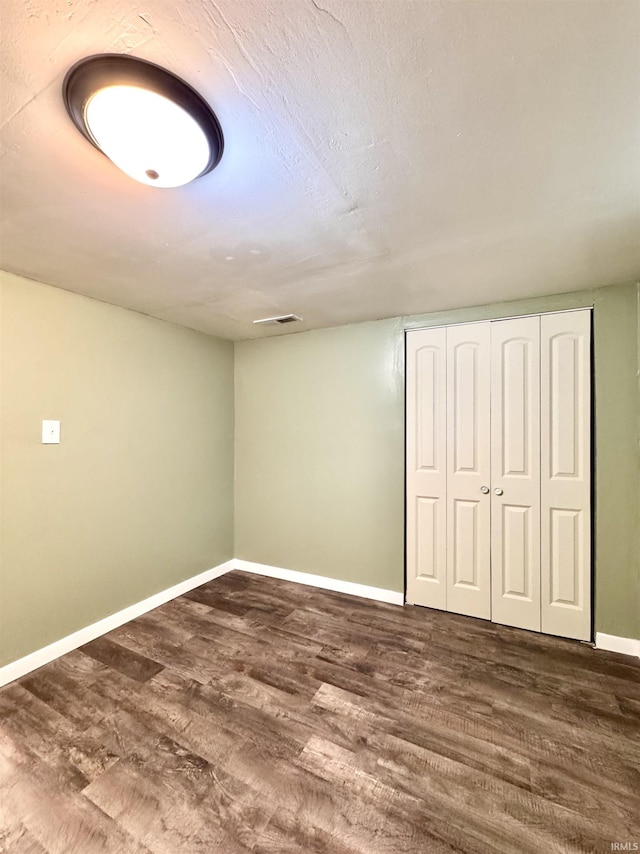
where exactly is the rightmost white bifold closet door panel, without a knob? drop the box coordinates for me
[540,310,591,640]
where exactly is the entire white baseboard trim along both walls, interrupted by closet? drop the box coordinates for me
[0,558,640,687]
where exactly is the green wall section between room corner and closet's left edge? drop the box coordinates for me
[236,320,404,590]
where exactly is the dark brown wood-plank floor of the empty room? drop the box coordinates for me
[0,572,640,854]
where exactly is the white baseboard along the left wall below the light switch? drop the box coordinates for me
[0,560,234,687]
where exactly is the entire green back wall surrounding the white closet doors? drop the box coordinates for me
[235,285,640,638]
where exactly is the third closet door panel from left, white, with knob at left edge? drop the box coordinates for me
[491,317,540,632]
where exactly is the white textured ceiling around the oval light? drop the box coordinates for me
[0,0,640,339]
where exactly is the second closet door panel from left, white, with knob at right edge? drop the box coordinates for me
[447,323,491,619]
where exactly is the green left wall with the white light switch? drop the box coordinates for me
[0,273,233,665]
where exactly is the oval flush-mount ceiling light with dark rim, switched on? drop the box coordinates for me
[63,53,224,187]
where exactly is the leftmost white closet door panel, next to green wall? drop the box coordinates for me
[407,328,447,609]
